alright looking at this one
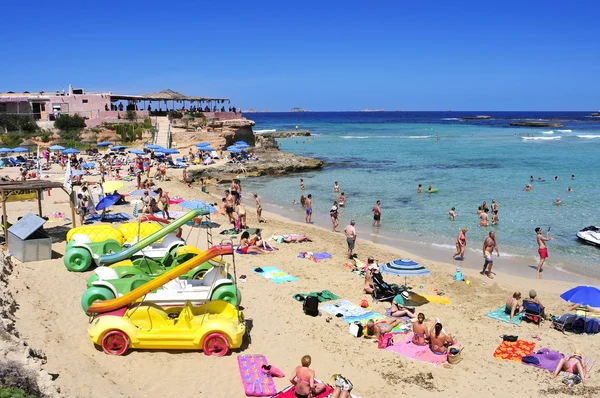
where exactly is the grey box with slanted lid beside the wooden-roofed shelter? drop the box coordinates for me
[8,213,52,263]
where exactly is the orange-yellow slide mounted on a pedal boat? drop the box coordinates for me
[87,243,233,314]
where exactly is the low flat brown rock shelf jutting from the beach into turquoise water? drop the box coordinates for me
[188,150,323,182]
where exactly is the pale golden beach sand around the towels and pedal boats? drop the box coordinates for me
[4,163,600,397]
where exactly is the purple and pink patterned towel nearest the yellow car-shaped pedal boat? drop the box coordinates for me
[238,355,277,397]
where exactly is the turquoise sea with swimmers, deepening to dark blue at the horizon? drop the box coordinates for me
[244,112,600,277]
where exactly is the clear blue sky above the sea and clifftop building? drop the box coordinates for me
[0,0,600,111]
